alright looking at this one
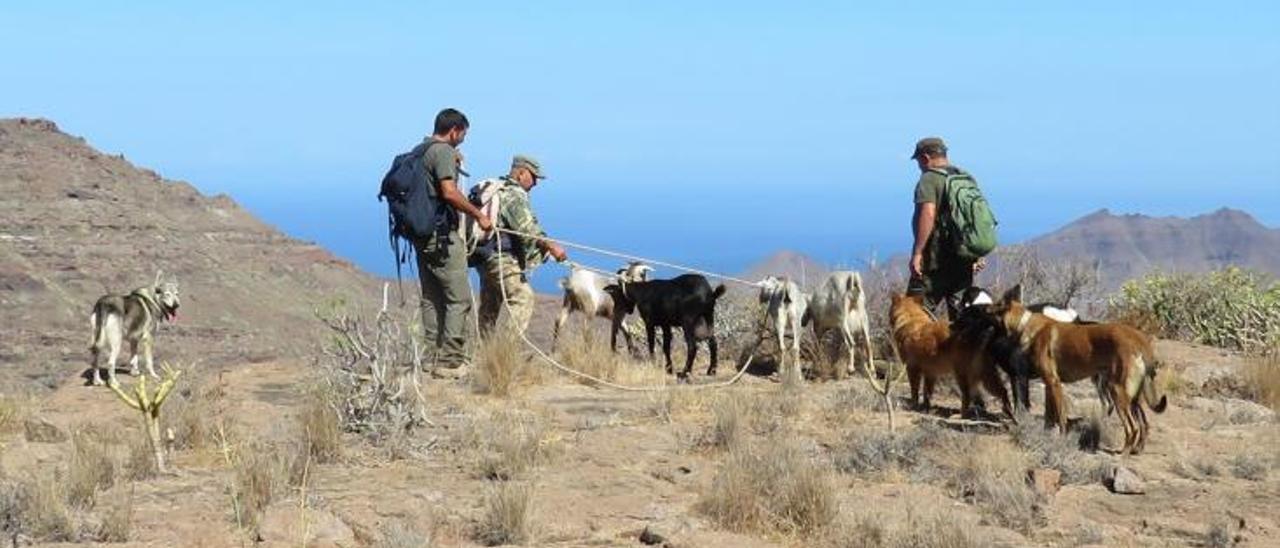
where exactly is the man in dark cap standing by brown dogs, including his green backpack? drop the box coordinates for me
[906,137,996,319]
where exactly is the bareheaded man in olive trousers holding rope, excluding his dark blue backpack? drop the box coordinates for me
[413,109,492,378]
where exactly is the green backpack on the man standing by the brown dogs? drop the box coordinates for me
[942,170,997,261]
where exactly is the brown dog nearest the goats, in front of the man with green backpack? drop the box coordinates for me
[888,293,1015,420]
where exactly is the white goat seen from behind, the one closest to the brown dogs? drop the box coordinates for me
[801,270,879,389]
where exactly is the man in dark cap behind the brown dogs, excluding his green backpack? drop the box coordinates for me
[906,137,986,319]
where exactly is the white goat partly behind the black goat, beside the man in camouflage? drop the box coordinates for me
[552,262,653,352]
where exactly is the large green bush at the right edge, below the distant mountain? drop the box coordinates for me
[1110,266,1280,352]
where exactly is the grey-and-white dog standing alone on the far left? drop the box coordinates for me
[88,273,180,385]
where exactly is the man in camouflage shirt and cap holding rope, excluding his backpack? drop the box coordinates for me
[472,155,567,333]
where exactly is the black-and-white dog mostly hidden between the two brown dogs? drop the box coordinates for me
[951,284,1110,414]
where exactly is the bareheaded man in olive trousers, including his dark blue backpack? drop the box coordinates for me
[379,109,492,378]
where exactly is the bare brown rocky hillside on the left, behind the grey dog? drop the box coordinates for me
[0,119,378,389]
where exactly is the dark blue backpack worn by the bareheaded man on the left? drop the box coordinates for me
[378,141,449,279]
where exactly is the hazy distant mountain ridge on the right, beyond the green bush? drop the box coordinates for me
[1024,209,1280,287]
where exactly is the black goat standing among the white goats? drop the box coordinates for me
[605,274,724,379]
